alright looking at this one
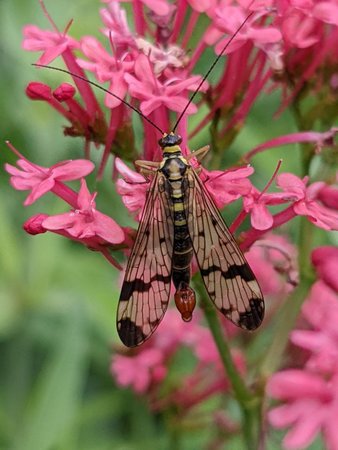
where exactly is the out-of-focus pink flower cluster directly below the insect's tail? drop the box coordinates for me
[111,309,245,413]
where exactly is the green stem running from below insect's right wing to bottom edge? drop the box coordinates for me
[196,280,260,450]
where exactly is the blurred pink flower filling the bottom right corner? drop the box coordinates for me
[267,370,338,450]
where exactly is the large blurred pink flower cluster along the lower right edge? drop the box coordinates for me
[267,247,338,450]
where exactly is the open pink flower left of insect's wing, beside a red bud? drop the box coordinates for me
[42,179,124,244]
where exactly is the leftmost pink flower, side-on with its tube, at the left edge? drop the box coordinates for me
[5,155,95,206]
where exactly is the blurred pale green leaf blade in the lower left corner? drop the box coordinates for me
[14,308,87,450]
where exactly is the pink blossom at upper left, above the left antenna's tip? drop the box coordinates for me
[22,25,79,64]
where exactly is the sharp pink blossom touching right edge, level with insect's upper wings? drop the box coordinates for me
[276,173,338,230]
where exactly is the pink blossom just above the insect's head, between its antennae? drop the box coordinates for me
[124,54,200,116]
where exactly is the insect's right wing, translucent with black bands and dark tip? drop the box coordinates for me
[185,168,264,330]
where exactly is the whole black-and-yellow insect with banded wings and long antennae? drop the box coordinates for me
[34,9,264,347]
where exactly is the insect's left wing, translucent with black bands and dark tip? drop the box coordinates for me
[117,172,174,347]
